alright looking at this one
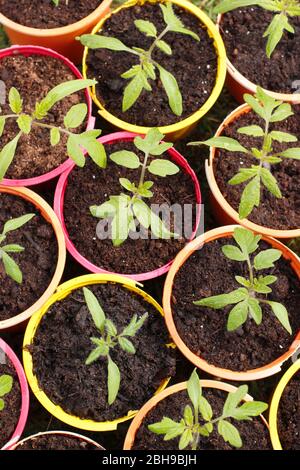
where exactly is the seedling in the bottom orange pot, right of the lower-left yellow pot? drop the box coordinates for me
[148,369,268,450]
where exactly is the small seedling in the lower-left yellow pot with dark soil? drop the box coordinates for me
[83,287,148,405]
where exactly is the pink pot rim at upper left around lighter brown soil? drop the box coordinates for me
[0,45,95,187]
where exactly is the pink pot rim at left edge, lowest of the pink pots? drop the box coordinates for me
[0,338,29,450]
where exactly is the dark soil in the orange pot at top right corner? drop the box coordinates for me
[221,7,300,93]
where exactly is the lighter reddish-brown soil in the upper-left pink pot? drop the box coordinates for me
[0,54,86,179]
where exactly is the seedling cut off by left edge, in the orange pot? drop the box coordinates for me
[0,214,35,284]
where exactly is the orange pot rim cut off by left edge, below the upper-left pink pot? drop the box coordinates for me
[0,185,66,331]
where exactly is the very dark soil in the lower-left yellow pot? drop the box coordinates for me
[29,284,175,421]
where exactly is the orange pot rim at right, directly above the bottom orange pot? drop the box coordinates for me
[163,225,300,381]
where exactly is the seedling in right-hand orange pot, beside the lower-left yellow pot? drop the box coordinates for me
[194,227,292,334]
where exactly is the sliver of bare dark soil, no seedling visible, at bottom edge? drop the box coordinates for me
[16,434,100,450]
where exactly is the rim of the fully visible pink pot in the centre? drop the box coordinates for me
[54,132,201,281]
